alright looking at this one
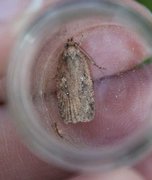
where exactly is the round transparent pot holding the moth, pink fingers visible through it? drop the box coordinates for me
[7,0,152,171]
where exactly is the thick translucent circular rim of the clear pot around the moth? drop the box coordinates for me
[7,0,152,171]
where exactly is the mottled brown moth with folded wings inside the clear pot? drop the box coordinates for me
[56,38,95,124]
